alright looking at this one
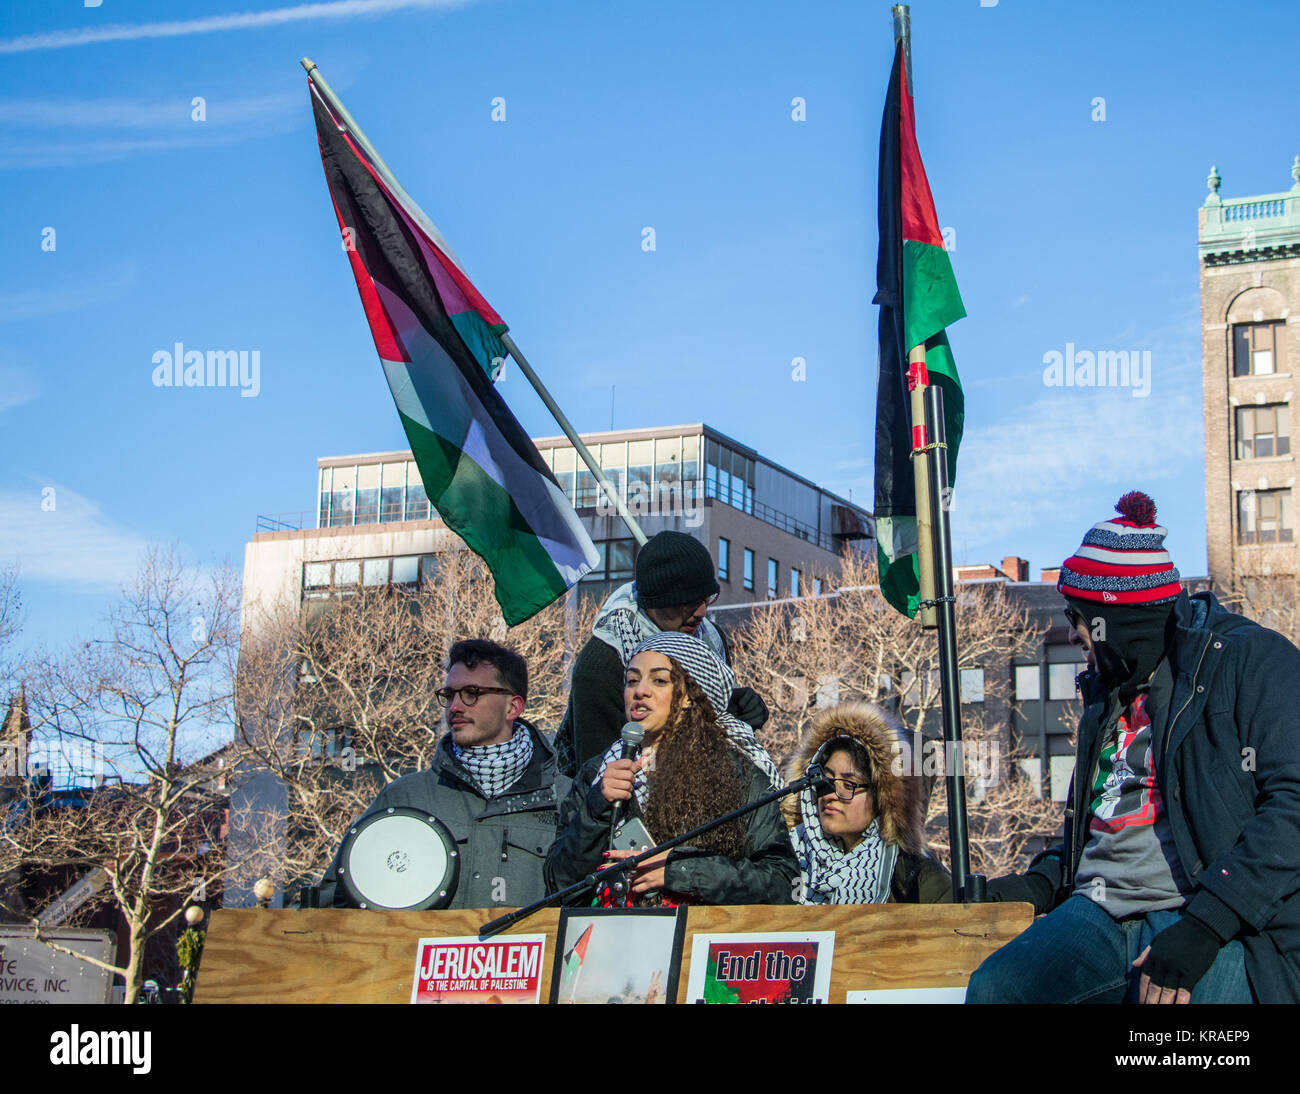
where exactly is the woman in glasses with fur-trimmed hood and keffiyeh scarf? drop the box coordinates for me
[781,703,953,904]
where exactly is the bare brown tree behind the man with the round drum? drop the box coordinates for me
[237,551,595,886]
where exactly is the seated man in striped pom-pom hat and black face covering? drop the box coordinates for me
[966,491,1300,1003]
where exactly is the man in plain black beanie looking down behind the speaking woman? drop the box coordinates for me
[555,530,767,776]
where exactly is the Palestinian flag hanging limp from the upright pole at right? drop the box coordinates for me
[872,43,966,616]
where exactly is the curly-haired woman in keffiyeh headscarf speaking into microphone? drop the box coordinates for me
[545,631,801,904]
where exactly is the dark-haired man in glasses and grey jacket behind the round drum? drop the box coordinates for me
[321,638,569,908]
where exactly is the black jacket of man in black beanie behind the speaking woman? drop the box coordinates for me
[555,629,768,774]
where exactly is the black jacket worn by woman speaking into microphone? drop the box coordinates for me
[546,754,800,904]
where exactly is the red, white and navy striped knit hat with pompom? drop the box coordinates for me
[1057,490,1183,604]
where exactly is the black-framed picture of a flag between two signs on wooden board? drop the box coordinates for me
[550,908,686,1003]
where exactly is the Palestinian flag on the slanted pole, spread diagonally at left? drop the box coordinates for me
[308,81,597,625]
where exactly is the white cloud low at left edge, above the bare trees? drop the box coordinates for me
[0,479,147,590]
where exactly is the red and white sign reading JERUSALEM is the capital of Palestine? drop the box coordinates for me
[411,934,546,1003]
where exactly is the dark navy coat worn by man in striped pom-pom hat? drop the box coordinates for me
[1013,592,1300,1003]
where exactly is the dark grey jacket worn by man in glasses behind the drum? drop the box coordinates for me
[320,719,571,908]
